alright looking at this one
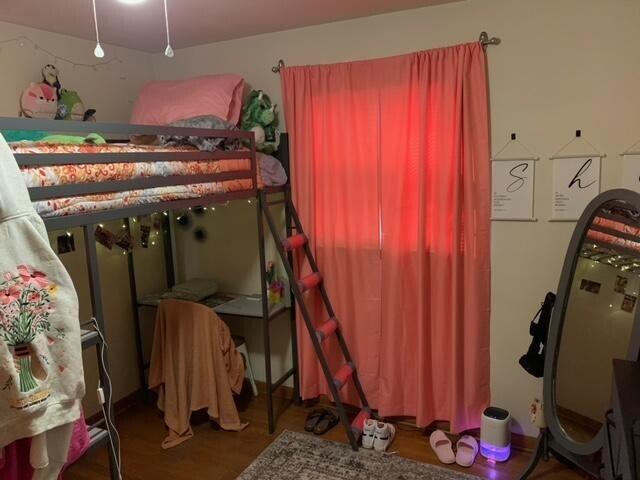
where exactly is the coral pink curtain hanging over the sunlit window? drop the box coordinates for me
[282,43,490,431]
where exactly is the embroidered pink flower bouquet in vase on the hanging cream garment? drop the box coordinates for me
[0,265,57,393]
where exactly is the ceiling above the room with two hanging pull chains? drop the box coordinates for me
[0,0,459,52]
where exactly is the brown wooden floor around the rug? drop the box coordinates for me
[65,389,584,480]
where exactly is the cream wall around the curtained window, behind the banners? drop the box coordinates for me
[153,0,640,435]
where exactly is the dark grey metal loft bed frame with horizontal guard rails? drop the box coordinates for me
[0,117,299,480]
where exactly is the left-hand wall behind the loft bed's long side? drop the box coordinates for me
[0,22,164,415]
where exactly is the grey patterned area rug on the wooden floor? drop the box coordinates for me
[238,431,479,480]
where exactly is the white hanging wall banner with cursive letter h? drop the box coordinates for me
[551,155,601,220]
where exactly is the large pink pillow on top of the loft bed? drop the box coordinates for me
[131,74,244,125]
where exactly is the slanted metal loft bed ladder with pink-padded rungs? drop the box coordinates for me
[259,188,371,450]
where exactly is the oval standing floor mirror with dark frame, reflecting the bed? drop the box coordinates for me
[520,190,640,480]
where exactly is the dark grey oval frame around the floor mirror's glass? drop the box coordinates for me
[543,189,640,456]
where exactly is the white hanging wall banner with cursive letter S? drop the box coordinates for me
[491,158,536,221]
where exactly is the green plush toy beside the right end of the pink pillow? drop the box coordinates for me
[241,90,278,154]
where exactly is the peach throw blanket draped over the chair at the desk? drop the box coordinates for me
[149,300,247,448]
